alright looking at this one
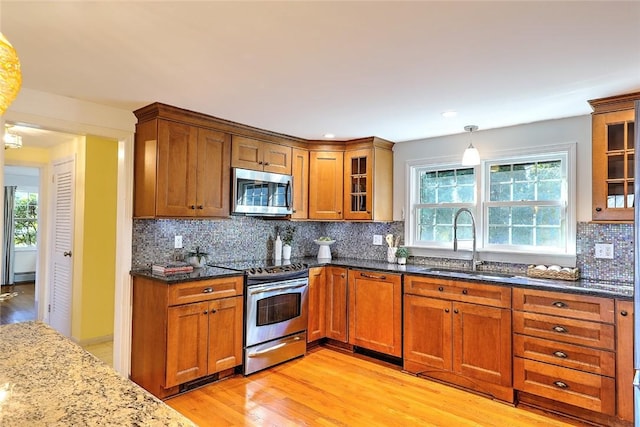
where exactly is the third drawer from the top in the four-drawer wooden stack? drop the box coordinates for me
[513,334,616,377]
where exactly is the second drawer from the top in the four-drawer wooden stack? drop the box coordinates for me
[513,311,615,350]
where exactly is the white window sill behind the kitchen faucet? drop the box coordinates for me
[409,247,576,267]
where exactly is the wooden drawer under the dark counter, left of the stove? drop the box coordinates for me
[169,276,244,305]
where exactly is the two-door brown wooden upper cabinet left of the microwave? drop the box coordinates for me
[134,119,231,217]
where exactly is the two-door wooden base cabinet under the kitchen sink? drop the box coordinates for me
[404,275,514,403]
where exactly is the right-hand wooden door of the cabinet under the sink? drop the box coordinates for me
[453,302,512,387]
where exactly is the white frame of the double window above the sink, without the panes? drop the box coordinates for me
[403,142,577,266]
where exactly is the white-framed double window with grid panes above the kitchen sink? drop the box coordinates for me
[406,144,575,262]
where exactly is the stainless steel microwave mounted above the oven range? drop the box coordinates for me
[232,168,293,216]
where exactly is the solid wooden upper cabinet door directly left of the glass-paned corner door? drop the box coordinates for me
[309,151,343,219]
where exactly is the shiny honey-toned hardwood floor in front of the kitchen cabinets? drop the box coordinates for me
[166,347,581,427]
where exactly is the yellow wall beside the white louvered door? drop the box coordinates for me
[74,136,118,342]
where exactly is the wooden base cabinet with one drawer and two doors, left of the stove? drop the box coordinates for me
[131,276,244,399]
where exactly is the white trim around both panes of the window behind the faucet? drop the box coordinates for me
[404,142,577,267]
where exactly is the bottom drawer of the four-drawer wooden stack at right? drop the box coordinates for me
[513,357,615,415]
